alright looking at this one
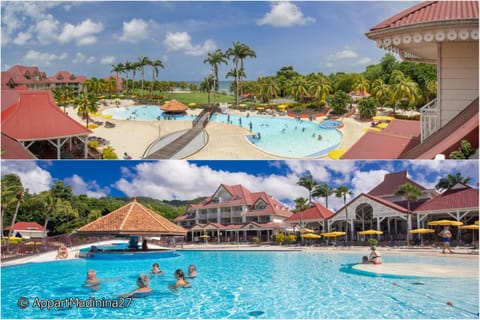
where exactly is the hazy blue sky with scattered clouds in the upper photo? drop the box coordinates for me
[1,1,416,80]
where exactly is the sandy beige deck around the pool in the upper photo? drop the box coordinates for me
[67,100,370,160]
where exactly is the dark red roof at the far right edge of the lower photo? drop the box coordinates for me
[415,183,478,212]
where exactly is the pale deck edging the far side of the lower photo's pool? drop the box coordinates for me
[1,240,479,279]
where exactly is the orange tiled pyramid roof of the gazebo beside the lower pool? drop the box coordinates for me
[77,198,187,236]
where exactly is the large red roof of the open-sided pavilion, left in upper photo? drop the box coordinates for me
[2,90,91,141]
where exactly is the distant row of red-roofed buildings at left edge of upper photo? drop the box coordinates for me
[2,65,87,94]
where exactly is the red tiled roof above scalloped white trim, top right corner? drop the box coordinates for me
[370,1,478,31]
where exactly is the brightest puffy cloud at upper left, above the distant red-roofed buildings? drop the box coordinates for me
[58,19,103,46]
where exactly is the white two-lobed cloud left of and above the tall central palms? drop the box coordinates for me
[163,32,217,56]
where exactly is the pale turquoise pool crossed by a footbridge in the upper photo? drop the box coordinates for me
[103,106,342,158]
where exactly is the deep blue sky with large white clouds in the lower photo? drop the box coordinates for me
[2,160,479,209]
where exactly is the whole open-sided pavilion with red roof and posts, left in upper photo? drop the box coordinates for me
[1,89,94,159]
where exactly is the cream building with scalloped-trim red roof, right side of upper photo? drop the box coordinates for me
[342,1,479,159]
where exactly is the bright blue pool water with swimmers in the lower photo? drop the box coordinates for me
[1,251,479,319]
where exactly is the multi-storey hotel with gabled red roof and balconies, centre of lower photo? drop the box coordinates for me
[175,184,293,242]
